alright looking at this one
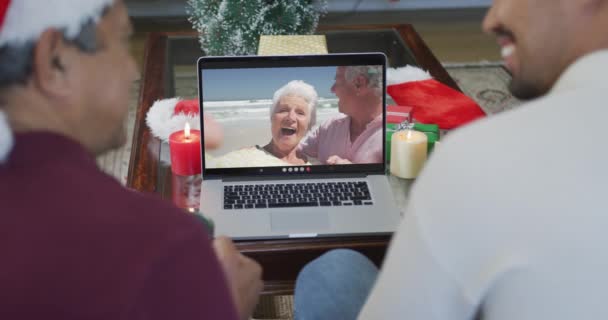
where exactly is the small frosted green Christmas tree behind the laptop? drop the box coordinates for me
[186,0,327,56]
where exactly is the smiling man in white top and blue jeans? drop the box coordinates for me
[295,0,608,320]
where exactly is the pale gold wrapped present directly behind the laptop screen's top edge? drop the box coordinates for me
[258,35,327,56]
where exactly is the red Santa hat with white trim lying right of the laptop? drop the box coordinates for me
[386,66,485,129]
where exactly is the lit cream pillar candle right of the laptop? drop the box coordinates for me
[390,130,428,179]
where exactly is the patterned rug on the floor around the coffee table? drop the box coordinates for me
[97,63,521,319]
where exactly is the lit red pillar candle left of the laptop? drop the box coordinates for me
[169,123,202,176]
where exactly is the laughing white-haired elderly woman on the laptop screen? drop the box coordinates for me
[206,80,319,168]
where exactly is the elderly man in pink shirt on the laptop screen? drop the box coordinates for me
[300,66,384,165]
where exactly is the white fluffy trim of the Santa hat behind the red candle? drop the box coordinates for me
[146,98,201,141]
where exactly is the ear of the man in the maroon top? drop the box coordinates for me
[32,29,72,97]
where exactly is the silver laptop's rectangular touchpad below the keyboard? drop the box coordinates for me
[270,209,329,232]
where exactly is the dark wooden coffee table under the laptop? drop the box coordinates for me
[127,24,459,294]
